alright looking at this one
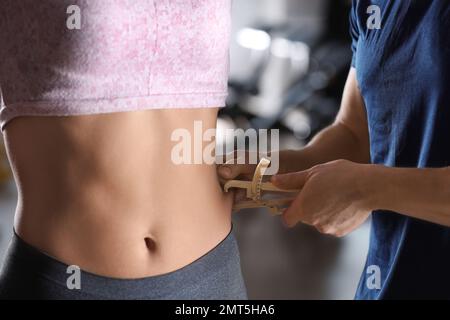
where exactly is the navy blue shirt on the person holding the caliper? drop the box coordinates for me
[350,0,450,299]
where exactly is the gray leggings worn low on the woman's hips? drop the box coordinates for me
[0,233,247,300]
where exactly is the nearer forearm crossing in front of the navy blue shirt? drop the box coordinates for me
[363,165,450,227]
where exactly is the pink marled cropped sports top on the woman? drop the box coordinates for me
[0,0,231,129]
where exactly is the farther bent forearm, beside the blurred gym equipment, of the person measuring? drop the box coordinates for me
[280,122,370,173]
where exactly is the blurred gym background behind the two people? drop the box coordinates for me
[0,0,369,299]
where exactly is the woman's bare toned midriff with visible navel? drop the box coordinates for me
[5,108,232,278]
